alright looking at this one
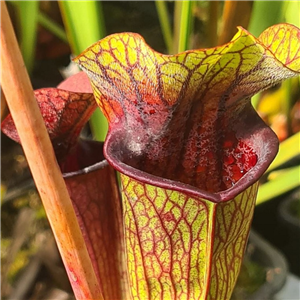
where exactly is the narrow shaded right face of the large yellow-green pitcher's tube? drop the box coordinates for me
[207,183,258,300]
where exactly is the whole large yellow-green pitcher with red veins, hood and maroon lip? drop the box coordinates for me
[75,24,300,300]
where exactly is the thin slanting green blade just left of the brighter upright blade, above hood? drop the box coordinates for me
[155,0,173,53]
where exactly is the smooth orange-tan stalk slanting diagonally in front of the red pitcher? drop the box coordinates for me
[0,0,103,300]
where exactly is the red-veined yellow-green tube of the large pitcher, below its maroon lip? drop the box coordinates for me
[122,176,257,300]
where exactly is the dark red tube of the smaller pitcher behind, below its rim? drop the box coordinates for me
[65,151,129,300]
